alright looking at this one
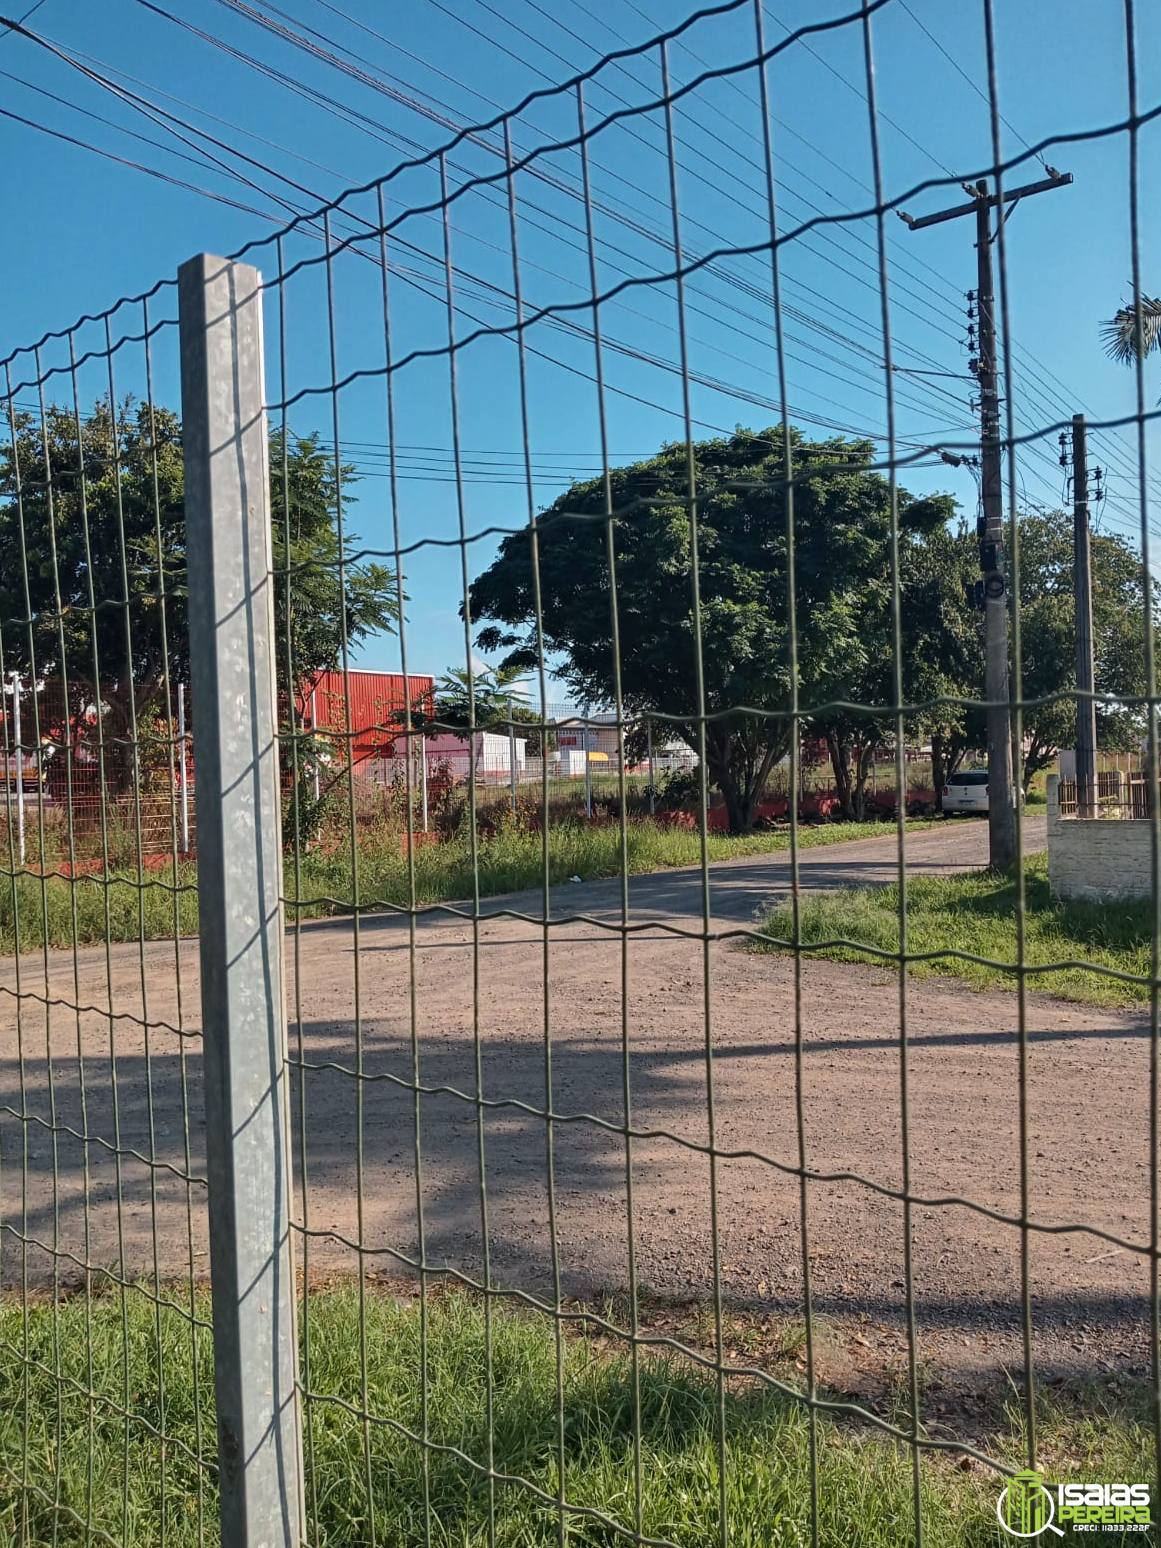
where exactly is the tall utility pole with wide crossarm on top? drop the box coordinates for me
[901,173,1073,872]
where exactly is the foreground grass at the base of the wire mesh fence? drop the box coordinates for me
[0,1286,1152,1548]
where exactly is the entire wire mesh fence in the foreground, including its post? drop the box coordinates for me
[0,0,1161,1545]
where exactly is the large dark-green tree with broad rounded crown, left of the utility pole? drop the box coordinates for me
[471,427,952,833]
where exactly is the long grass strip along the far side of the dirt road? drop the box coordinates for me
[0,819,921,952]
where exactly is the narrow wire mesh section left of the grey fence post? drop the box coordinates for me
[0,286,215,1543]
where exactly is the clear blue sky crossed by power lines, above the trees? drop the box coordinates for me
[0,0,1161,702]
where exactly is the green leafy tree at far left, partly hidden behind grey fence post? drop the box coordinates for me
[0,401,396,785]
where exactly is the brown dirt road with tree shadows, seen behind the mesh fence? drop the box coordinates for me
[0,819,1150,1364]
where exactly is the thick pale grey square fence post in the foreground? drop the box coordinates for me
[178,254,305,1548]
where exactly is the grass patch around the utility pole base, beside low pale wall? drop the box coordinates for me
[760,853,1152,1006]
